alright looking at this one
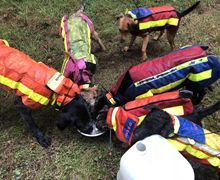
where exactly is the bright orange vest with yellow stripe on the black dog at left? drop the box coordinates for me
[0,40,79,109]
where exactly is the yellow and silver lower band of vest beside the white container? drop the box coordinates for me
[168,137,220,168]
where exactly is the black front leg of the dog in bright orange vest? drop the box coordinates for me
[15,97,50,148]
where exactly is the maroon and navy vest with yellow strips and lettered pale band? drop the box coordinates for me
[106,45,220,105]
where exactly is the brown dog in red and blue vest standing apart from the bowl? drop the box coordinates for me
[117,1,200,61]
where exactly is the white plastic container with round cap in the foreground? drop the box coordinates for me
[117,135,194,180]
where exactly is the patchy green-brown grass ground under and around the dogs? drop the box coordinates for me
[0,0,220,179]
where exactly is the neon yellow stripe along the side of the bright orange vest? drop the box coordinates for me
[0,75,50,105]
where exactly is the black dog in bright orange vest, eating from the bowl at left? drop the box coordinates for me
[0,40,96,148]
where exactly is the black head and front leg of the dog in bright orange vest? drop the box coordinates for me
[15,95,93,148]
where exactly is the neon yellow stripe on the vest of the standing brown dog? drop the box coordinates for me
[139,18,179,30]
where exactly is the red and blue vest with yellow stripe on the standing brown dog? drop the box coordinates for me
[127,6,179,33]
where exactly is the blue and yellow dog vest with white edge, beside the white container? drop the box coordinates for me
[168,115,220,170]
